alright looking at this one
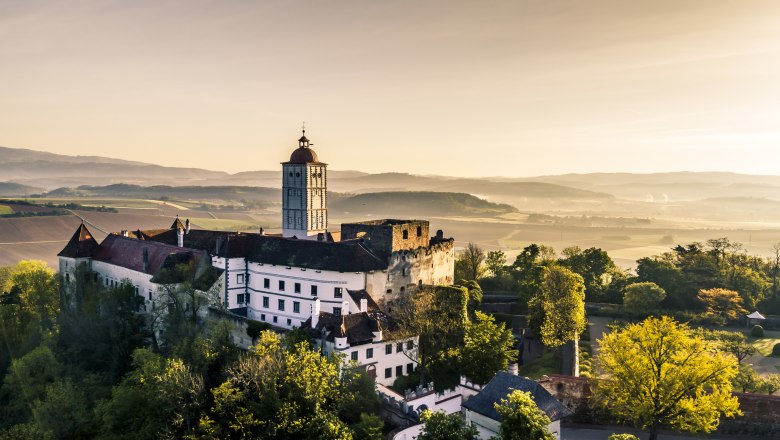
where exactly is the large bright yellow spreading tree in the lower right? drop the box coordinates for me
[594,317,740,440]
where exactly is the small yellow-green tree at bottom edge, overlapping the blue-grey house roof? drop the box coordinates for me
[495,390,555,440]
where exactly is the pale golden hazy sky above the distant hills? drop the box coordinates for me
[0,0,780,180]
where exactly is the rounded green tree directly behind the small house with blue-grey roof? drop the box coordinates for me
[460,312,518,384]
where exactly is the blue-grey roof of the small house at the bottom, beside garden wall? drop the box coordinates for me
[463,371,572,422]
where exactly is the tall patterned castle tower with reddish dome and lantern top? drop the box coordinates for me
[282,128,328,239]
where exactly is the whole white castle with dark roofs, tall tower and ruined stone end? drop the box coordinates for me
[58,132,455,384]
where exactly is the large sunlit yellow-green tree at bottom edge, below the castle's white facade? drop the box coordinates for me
[198,331,354,439]
